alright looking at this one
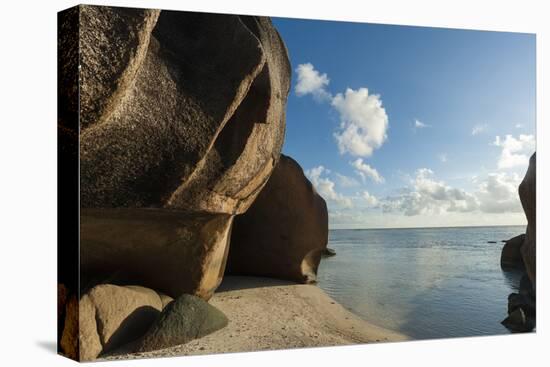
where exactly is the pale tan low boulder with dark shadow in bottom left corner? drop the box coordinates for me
[73,284,172,361]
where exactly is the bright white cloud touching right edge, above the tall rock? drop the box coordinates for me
[493,134,536,169]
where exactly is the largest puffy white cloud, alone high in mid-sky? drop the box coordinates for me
[332,88,388,157]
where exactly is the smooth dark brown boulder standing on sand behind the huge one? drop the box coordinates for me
[227,155,328,283]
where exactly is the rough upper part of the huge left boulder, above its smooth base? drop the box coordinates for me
[80,6,290,214]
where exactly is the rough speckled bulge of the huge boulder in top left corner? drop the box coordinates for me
[79,6,160,129]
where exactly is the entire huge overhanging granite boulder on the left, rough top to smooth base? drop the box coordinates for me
[64,5,290,299]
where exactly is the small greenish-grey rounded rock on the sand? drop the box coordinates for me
[135,294,228,352]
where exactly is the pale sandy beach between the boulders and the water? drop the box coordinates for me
[106,276,409,360]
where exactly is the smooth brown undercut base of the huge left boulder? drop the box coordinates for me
[80,209,233,299]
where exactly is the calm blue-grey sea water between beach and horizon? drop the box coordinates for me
[318,226,525,339]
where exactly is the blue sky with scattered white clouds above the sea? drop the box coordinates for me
[273,18,536,228]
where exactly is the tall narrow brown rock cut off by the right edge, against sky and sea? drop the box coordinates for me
[519,153,537,289]
